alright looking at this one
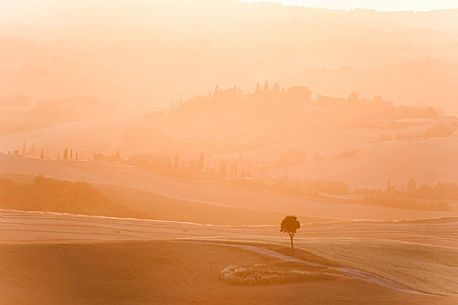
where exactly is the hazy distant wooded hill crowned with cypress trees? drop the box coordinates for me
[166,82,438,131]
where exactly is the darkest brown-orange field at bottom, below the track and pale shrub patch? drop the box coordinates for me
[0,241,453,305]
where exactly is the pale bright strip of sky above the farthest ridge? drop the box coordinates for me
[245,0,458,11]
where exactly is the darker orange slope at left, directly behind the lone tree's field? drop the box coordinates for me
[0,174,330,225]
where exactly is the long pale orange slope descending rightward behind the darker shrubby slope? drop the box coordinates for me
[0,155,457,223]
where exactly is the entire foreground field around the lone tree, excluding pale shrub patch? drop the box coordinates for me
[0,210,458,305]
